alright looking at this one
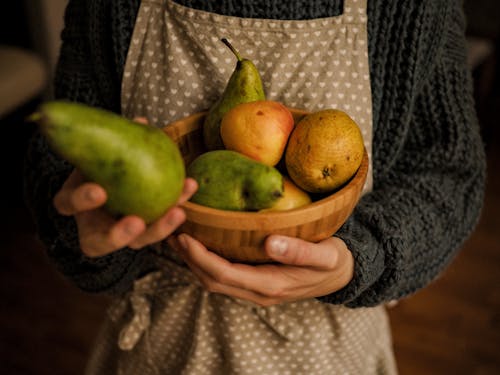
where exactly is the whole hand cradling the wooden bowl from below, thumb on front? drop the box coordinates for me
[169,234,354,306]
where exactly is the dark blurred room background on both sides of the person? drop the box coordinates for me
[0,0,500,375]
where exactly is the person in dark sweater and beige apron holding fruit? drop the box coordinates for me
[22,0,486,374]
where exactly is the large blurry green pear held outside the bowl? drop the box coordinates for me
[32,101,185,223]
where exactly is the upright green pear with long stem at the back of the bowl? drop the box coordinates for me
[203,38,266,150]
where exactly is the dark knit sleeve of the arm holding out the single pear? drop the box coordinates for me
[25,0,153,293]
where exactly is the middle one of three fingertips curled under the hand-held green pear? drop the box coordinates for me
[77,214,146,257]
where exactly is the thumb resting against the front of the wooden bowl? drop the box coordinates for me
[264,235,347,270]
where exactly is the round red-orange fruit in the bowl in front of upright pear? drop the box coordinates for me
[220,100,294,166]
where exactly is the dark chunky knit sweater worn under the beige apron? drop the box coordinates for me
[22,0,486,307]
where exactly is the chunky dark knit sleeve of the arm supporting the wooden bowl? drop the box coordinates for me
[320,1,486,307]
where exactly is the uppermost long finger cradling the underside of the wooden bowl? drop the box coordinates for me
[178,233,291,299]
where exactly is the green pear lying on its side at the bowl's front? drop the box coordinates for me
[187,150,284,211]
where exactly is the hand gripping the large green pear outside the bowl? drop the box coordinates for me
[54,169,198,257]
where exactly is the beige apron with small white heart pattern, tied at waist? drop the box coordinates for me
[87,0,396,375]
